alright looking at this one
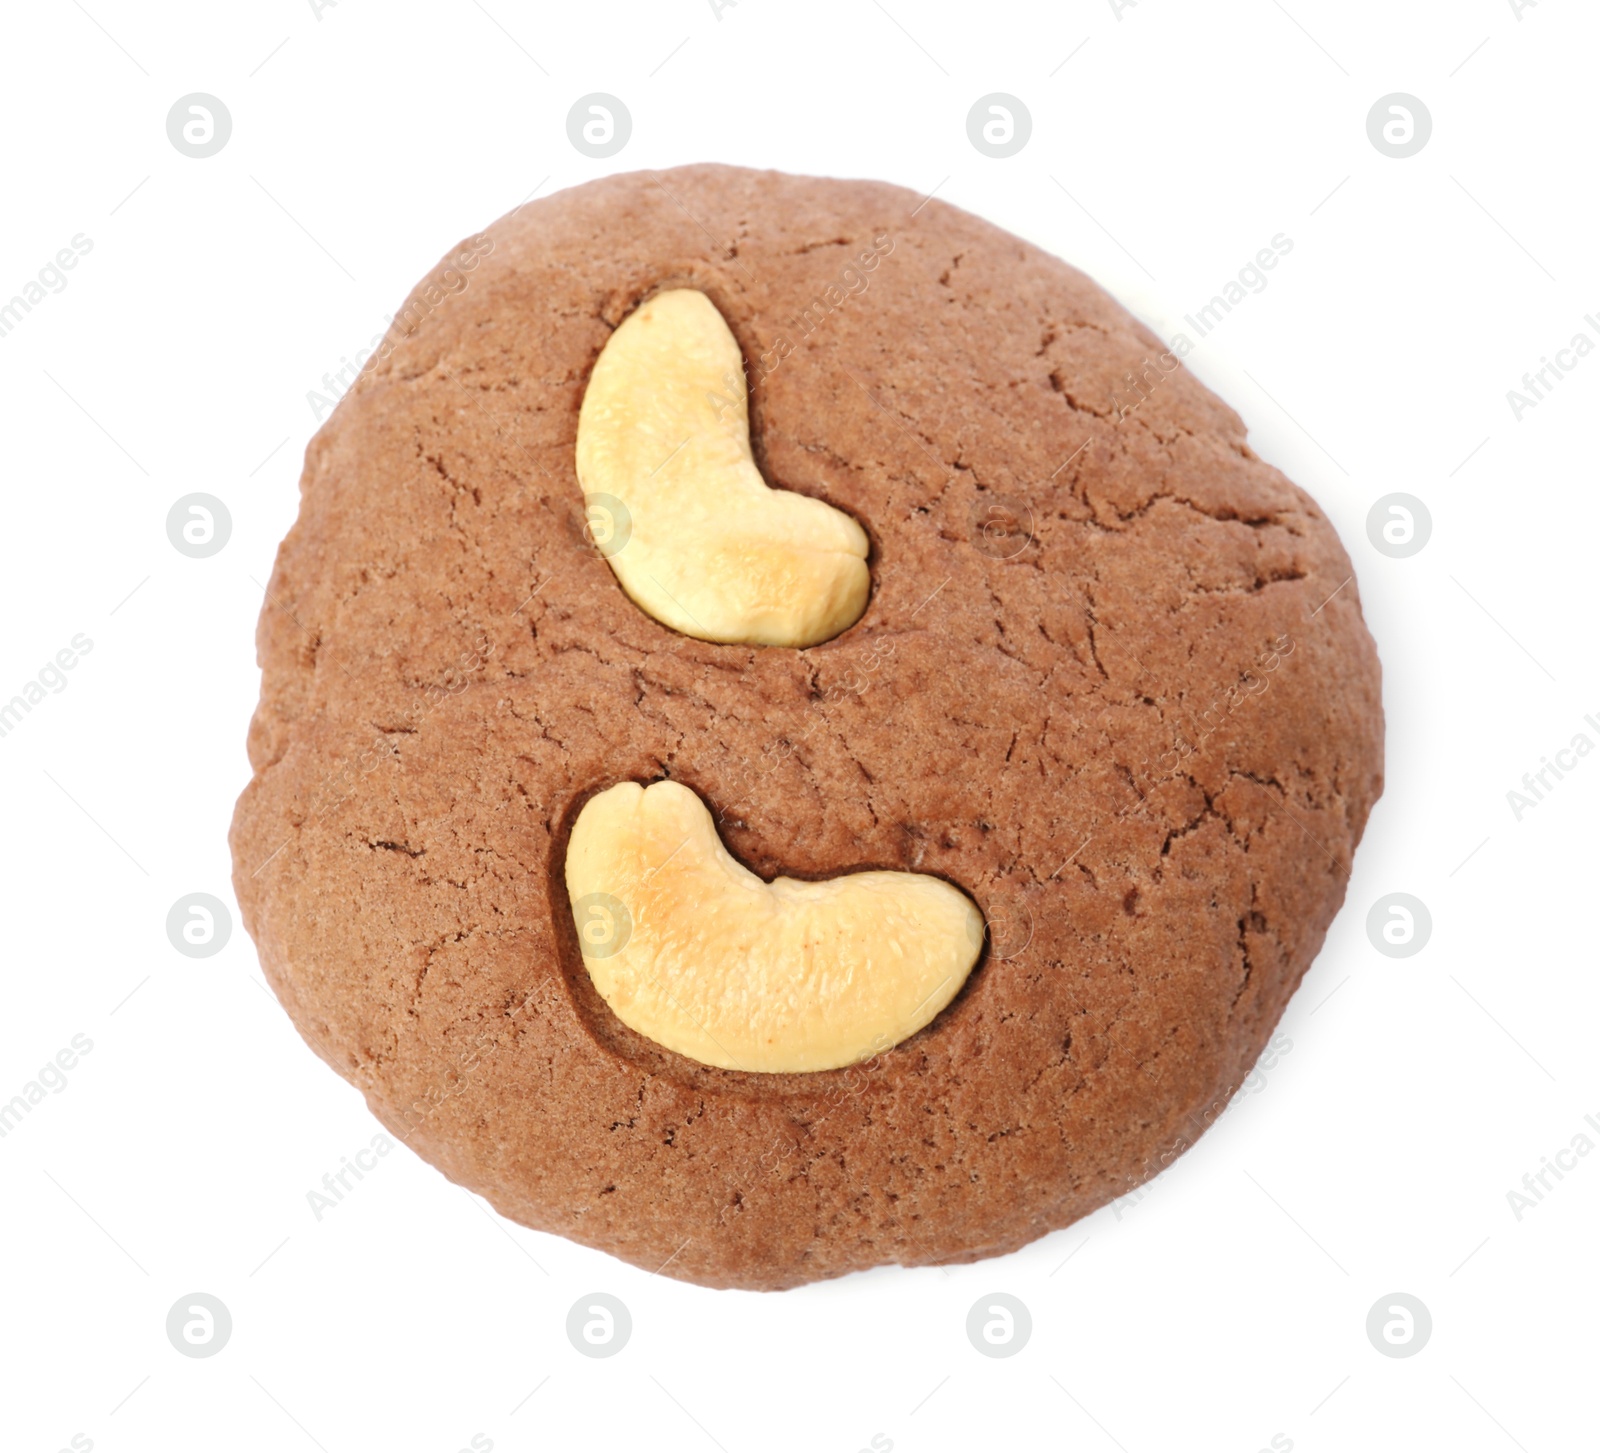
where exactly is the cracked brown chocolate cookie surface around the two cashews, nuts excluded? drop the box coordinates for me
[232,166,1382,1288]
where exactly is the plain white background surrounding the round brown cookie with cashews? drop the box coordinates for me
[0,0,1600,1453]
